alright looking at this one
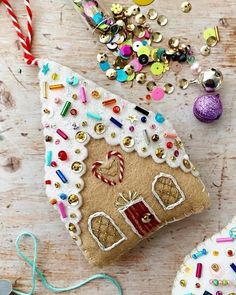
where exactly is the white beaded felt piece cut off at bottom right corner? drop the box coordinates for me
[172,217,236,295]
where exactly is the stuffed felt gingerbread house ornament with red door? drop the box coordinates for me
[39,60,209,266]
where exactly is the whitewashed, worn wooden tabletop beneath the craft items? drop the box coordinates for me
[0,0,236,295]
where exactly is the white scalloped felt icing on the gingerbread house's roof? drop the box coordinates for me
[39,60,198,245]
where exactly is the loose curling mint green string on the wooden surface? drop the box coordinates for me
[13,232,123,295]
